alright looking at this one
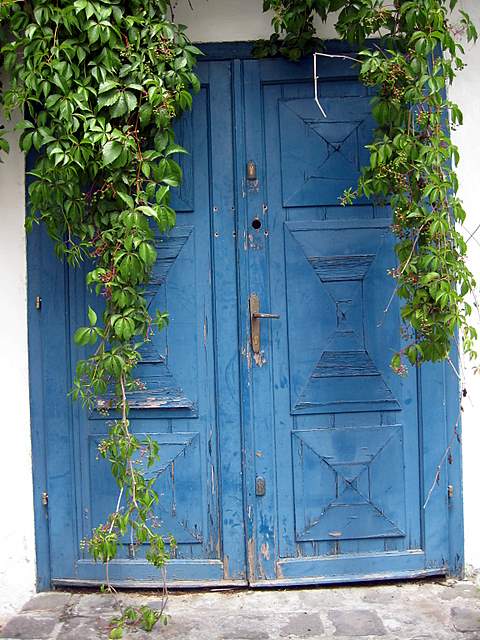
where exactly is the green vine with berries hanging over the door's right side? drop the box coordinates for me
[257,0,477,373]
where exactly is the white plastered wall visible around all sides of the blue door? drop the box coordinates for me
[0,0,480,616]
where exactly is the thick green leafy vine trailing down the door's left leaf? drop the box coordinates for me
[0,0,200,612]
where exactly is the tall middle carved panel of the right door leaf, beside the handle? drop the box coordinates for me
[286,221,399,413]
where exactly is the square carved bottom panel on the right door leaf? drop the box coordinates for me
[293,425,405,542]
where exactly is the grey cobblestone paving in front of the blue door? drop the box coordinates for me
[0,581,480,640]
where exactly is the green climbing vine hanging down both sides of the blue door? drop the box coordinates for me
[0,0,477,637]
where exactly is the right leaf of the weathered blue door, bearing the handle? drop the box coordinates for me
[243,61,447,584]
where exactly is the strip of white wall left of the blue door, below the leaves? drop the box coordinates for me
[0,114,35,615]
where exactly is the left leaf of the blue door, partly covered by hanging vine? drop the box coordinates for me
[36,63,245,584]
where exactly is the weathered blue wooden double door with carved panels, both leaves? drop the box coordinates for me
[32,60,461,586]
